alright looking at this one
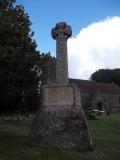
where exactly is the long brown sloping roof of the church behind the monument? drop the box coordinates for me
[69,79,120,95]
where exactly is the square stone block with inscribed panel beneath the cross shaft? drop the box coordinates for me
[43,85,81,107]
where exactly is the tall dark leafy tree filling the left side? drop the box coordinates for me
[0,0,51,114]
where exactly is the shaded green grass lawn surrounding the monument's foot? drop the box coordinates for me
[0,114,120,160]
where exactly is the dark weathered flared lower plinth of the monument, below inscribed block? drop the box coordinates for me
[30,107,92,149]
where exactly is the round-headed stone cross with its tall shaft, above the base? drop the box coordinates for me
[51,22,72,85]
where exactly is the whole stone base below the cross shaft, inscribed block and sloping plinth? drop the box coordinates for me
[30,85,92,149]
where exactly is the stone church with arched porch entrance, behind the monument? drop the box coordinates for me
[69,79,120,113]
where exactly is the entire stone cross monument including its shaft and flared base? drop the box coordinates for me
[30,22,92,149]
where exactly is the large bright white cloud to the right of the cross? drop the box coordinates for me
[68,17,120,79]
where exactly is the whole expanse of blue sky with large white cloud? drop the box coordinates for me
[17,0,120,79]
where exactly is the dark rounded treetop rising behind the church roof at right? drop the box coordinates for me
[90,68,120,86]
